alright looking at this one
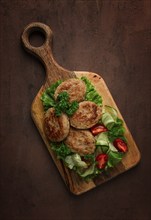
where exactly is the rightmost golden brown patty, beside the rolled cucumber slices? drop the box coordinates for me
[70,101,102,129]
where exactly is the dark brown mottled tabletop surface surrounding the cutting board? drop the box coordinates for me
[0,0,151,220]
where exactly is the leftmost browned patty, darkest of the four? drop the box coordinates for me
[44,108,70,142]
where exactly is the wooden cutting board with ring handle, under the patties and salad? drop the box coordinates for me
[22,22,140,195]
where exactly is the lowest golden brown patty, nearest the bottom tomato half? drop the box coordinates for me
[65,128,95,156]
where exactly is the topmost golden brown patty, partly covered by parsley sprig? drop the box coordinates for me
[54,78,86,102]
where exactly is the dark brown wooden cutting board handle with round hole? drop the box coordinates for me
[21,22,72,81]
